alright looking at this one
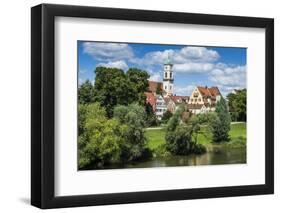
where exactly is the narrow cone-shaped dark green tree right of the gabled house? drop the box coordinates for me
[212,98,231,142]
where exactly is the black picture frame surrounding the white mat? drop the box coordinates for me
[31,4,274,209]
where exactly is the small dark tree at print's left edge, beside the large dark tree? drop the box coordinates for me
[78,80,93,104]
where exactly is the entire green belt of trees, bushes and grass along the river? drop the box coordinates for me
[78,67,246,170]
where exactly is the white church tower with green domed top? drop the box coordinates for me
[163,56,174,95]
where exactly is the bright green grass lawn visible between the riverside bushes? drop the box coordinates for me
[145,123,246,150]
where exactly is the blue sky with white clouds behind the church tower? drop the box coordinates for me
[78,41,247,96]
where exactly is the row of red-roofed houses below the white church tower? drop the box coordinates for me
[145,81,221,120]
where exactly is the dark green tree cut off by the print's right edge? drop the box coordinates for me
[227,89,247,121]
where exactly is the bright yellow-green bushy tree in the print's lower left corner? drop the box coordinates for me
[78,103,128,169]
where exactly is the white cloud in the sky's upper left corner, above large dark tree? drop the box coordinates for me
[83,42,134,61]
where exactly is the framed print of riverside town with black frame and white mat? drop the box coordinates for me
[31,4,274,208]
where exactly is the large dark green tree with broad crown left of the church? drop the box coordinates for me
[93,67,149,118]
